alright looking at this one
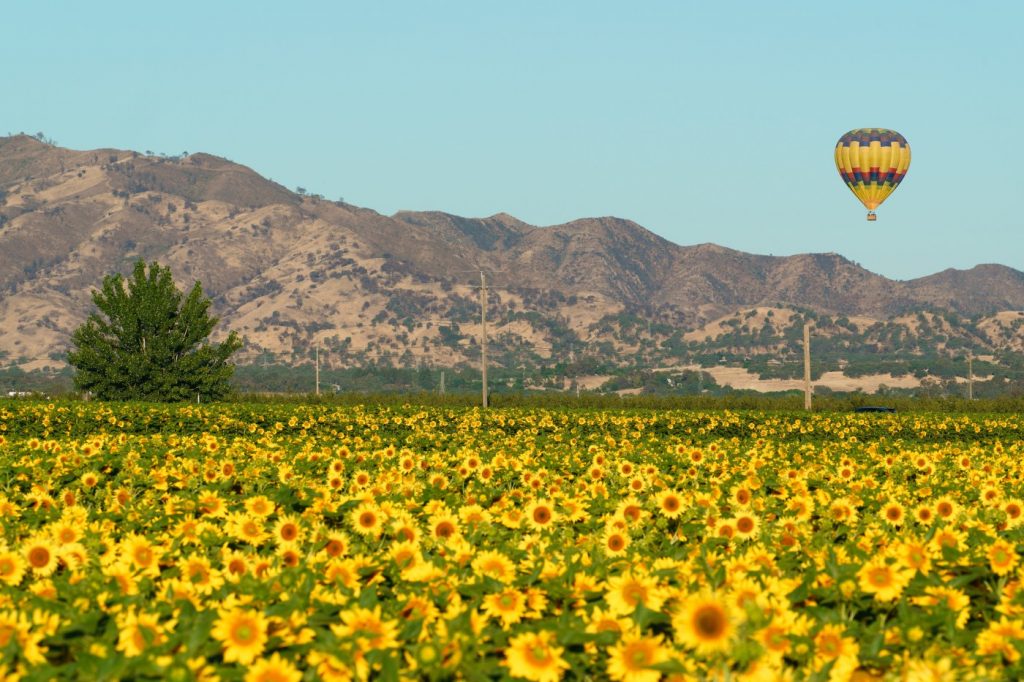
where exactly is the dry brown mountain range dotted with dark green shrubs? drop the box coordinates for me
[0,135,1024,391]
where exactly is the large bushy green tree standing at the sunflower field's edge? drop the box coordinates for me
[68,260,242,401]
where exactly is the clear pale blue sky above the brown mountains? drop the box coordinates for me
[0,0,1024,279]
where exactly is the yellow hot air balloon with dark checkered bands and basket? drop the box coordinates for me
[836,128,910,220]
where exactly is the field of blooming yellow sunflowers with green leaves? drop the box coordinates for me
[0,401,1024,682]
